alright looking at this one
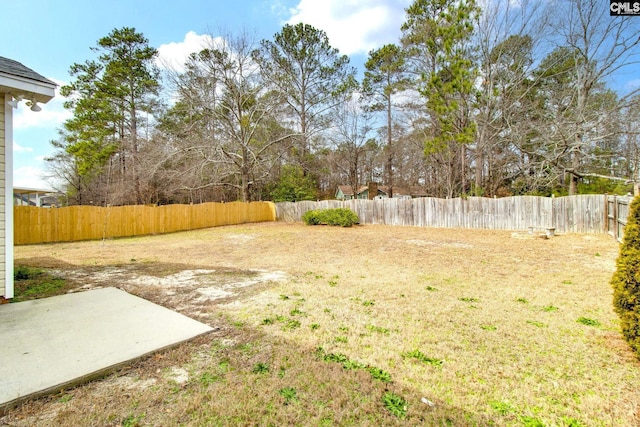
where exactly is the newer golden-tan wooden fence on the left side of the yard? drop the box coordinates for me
[14,202,275,245]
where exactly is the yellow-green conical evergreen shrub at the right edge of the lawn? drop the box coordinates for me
[611,197,640,357]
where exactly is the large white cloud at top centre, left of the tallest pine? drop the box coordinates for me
[287,0,411,55]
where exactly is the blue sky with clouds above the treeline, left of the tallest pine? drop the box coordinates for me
[0,0,411,188]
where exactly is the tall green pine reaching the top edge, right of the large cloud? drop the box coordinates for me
[402,0,479,197]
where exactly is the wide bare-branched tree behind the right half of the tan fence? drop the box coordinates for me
[161,32,292,201]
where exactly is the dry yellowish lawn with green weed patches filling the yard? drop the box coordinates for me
[0,223,640,426]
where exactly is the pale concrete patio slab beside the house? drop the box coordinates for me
[0,288,212,412]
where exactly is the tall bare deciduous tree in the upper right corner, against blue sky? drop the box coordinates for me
[549,0,640,194]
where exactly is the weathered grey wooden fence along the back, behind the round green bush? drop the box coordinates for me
[276,195,606,233]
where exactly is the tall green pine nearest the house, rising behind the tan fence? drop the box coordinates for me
[54,27,160,203]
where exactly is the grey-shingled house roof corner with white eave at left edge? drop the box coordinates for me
[0,56,57,103]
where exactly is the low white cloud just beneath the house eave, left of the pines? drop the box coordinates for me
[13,77,72,129]
